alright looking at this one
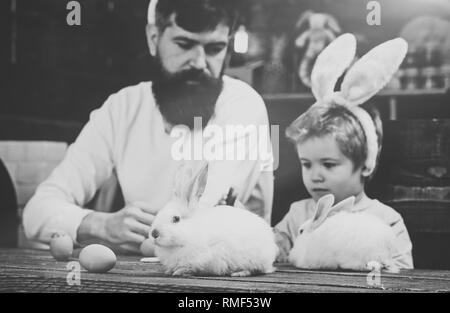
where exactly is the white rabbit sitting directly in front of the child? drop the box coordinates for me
[289,194,399,273]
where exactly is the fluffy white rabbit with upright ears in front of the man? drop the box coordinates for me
[150,161,278,276]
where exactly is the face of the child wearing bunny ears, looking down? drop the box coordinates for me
[297,135,364,203]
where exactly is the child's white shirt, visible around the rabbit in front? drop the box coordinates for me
[274,196,414,269]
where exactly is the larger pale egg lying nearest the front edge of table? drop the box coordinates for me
[79,244,117,273]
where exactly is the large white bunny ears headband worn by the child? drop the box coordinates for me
[302,33,408,175]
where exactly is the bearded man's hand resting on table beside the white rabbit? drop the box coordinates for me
[77,203,157,253]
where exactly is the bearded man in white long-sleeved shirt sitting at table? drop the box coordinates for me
[23,0,273,253]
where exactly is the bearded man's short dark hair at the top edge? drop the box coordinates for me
[155,0,242,34]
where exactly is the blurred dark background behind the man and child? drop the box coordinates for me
[0,0,450,269]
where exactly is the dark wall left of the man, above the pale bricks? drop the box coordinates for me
[0,0,153,122]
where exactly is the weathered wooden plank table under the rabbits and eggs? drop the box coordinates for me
[0,249,450,293]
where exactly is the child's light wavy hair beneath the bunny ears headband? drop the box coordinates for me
[286,103,383,176]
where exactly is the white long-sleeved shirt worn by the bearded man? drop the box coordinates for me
[23,76,273,242]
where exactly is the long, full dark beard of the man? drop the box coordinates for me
[152,57,223,129]
